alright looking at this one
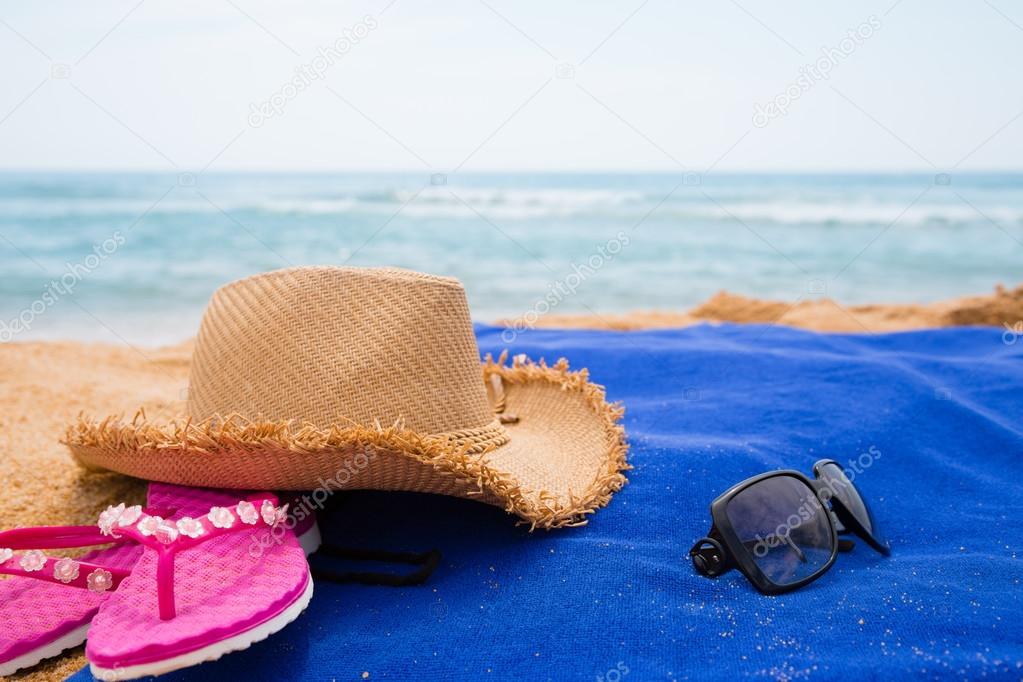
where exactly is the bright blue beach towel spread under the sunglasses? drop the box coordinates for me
[76,325,1023,682]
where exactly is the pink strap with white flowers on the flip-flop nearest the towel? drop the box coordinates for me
[101,493,287,621]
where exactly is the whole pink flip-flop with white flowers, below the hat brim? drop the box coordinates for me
[85,486,318,680]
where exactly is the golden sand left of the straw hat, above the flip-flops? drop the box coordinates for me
[0,343,191,680]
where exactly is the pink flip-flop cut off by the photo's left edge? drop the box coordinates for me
[0,485,183,677]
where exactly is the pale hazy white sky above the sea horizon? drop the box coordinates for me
[0,0,1023,172]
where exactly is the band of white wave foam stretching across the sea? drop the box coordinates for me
[0,192,1023,227]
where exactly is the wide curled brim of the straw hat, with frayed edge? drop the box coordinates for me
[63,356,630,529]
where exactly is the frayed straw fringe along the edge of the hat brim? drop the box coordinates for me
[61,352,632,531]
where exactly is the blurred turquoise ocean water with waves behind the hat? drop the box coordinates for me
[0,167,1023,345]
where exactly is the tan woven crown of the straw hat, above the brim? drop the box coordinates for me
[188,267,494,434]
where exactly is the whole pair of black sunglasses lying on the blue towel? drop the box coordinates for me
[690,459,891,594]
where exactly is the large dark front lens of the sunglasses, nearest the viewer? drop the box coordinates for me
[725,475,835,585]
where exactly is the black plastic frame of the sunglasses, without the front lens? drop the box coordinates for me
[690,459,891,594]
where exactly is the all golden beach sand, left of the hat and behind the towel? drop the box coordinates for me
[0,286,1023,680]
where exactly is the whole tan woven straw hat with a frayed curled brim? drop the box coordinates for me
[63,267,629,529]
